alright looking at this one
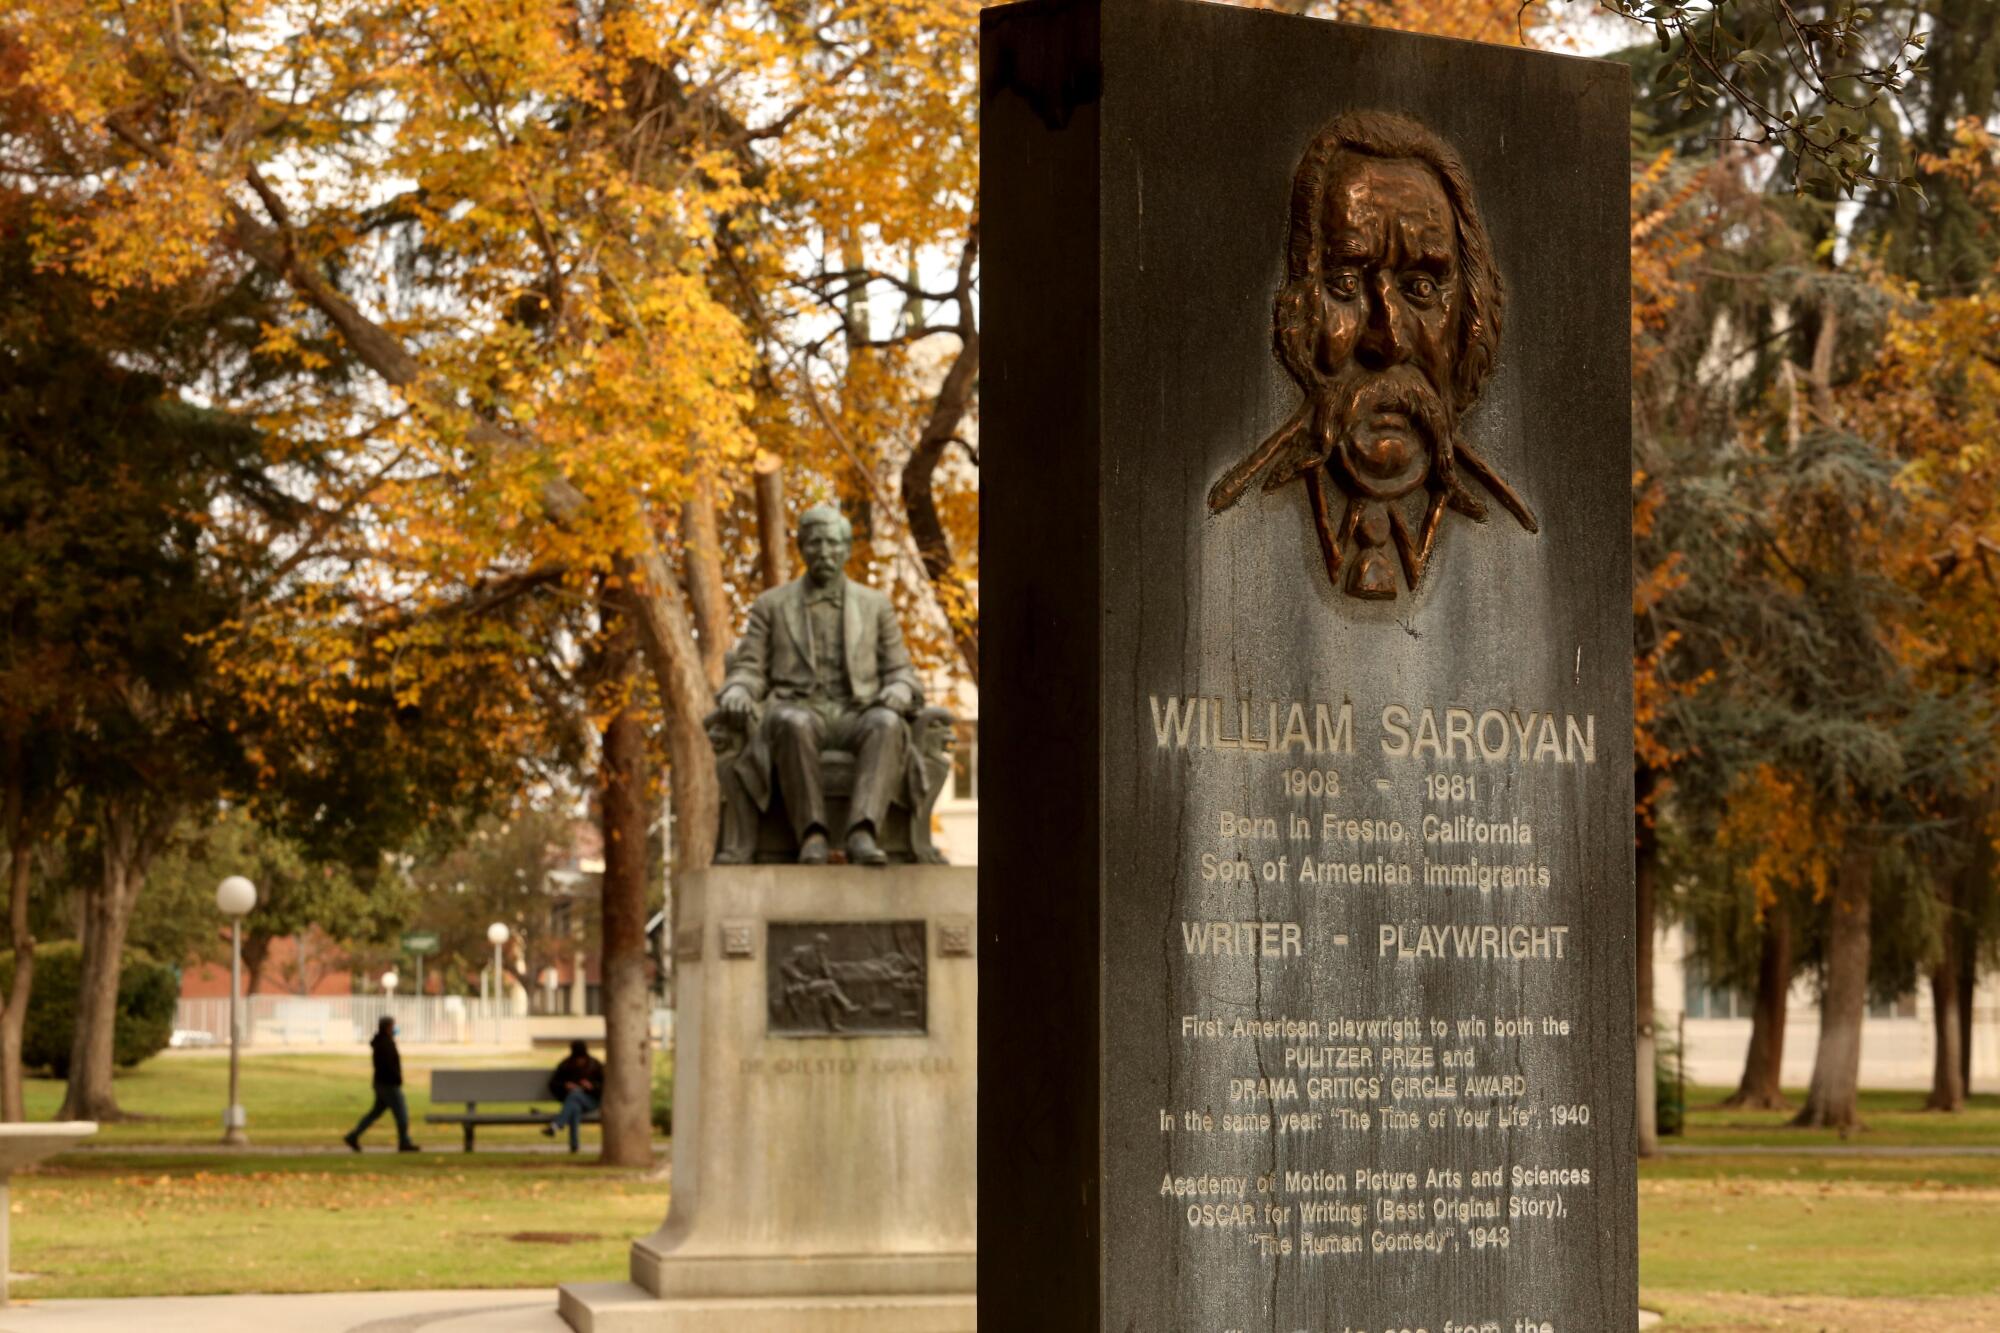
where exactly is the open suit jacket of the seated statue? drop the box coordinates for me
[722,578,924,709]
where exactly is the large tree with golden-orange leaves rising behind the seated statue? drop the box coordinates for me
[0,0,978,1144]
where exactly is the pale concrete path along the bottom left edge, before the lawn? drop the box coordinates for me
[0,1291,570,1333]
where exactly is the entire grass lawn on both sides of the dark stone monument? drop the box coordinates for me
[12,1053,2000,1312]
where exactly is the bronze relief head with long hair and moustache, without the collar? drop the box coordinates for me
[1272,112,1500,500]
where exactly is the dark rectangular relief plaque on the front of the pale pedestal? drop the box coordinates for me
[764,921,930,1037]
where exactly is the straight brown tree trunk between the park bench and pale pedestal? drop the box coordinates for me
[598,688,652,1167]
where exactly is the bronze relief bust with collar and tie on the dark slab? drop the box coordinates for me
[1208,112,1538,598]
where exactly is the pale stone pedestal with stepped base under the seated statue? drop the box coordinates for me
[562,865,978,1333]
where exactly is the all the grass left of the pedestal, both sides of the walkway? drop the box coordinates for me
[12,1051,666,1299]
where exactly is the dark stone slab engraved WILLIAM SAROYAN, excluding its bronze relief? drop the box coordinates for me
[980,0,1636,1333]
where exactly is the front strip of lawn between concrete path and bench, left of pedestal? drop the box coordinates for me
[12,1153,666,1299]
